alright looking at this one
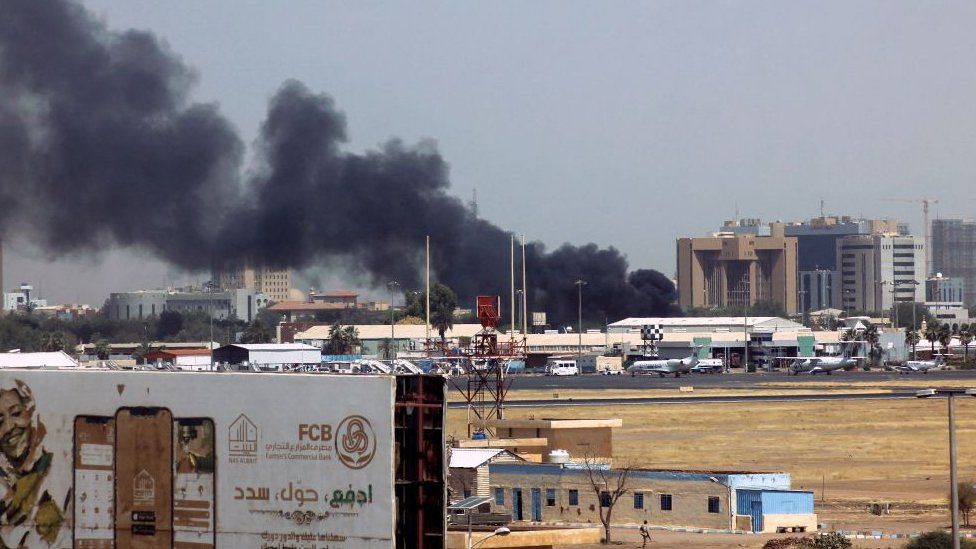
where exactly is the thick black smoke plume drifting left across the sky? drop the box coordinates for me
[0,0,675,323]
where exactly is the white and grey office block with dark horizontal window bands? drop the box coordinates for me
[837,235,925,312]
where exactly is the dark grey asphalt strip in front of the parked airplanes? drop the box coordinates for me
[512,370,976,392]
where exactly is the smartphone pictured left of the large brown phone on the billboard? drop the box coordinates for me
[73,416,115,549]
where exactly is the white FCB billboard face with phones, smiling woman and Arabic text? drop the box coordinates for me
[0,370,395,549]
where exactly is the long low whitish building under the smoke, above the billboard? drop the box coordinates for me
[104,288,269,322]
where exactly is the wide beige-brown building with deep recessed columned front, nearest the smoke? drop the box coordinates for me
[677,225,797,314]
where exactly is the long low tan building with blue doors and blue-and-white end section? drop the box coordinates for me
[489,463,817,532]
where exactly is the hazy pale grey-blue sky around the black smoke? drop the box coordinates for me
[4,0,976,305]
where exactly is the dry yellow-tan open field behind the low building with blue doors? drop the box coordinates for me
[448,390,976,547]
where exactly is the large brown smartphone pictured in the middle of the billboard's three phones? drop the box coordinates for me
[115,408,173,549]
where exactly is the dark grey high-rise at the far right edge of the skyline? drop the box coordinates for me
[929,219,976,307]
